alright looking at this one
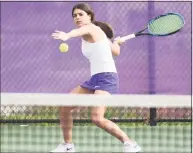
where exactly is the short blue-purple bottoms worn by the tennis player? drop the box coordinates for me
[80,72,119,94]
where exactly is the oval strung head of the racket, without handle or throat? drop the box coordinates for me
[148,14,184,35]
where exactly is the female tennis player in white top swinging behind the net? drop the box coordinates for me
[51,3,141,152]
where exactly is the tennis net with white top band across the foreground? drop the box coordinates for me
[1,93,192,152]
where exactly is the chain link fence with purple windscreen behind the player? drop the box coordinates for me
[1,2,191,122]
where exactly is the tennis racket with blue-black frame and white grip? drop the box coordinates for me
[121,13,185,42]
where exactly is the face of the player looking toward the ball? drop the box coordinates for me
[72,9,91,27]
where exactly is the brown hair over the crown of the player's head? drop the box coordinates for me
[72,3,94,22]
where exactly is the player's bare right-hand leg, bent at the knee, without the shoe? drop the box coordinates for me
[91,90,131,142]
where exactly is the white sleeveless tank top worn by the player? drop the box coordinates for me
[82,35,117,76]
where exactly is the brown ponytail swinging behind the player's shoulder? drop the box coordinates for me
[93,21,114,39]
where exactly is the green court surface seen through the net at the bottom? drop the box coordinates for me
[1,124,191,152]
